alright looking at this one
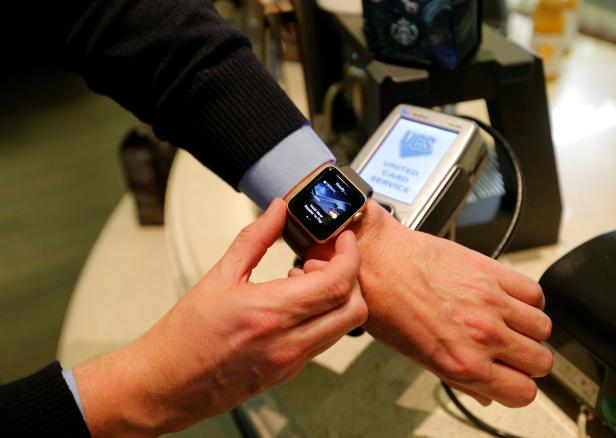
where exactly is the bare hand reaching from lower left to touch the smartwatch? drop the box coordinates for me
[74,199,368,436]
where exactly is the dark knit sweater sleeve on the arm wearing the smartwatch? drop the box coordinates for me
[58,0,305,187]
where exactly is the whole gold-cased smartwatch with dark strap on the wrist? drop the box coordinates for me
[283,165,372,258]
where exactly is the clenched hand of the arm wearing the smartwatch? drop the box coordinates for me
[310,201,552,407]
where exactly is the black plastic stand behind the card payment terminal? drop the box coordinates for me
[332,15,562,253]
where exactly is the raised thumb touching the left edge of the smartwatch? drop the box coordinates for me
[216,198,287,284]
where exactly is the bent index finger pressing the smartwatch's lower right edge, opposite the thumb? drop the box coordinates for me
[265,232,360,327]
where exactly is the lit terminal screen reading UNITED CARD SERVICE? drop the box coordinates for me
[359,118,458,205]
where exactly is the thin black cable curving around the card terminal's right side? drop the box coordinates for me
[441,116,525,438]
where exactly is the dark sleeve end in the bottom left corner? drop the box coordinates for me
[0,362,90,437]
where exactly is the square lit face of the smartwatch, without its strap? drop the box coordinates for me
[289,167,366,241]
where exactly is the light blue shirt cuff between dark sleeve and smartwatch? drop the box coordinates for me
[239,125,335,210]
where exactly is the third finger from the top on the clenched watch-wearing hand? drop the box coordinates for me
[496,331,553,377]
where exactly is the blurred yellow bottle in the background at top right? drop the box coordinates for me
[533,0,564,80]
